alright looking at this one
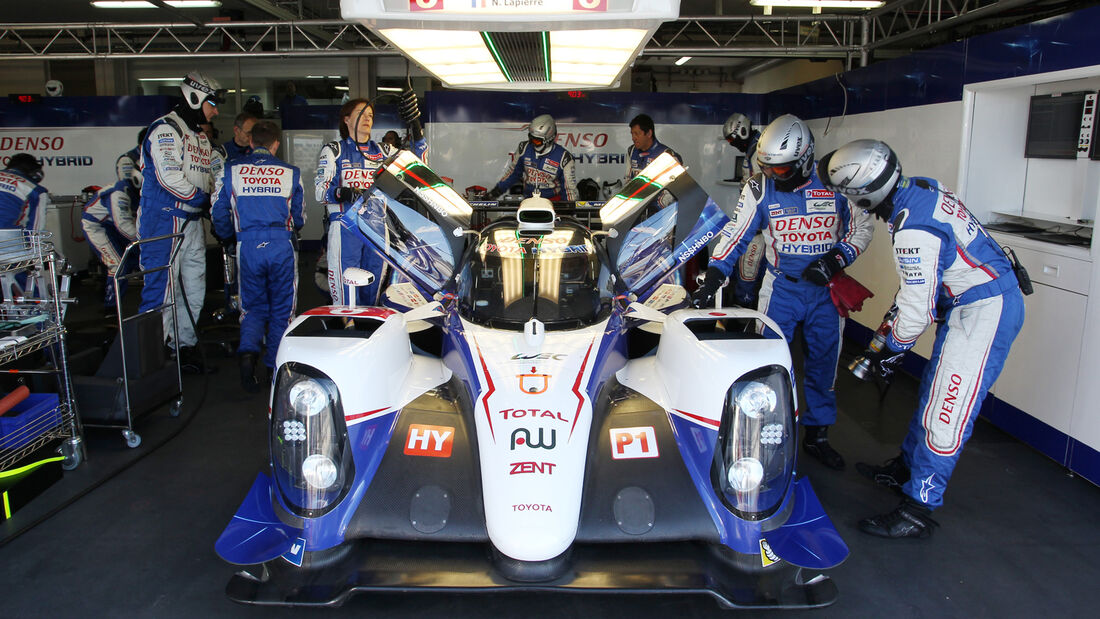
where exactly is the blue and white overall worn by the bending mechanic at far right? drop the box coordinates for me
[886,177,1024,509]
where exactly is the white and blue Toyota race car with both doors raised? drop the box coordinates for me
[216,152,848,608]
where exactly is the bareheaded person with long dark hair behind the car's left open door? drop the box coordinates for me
[314,90,428,306]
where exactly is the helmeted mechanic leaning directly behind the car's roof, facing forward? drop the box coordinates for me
[488,114,576,200]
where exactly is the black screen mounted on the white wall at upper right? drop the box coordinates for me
[1024,92,1086,159]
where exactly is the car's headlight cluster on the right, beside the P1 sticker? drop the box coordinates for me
[711,365,794,520]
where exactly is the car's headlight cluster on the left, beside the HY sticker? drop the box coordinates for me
[271,363,354,518]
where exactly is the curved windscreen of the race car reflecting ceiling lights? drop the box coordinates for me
[459,221,611,330]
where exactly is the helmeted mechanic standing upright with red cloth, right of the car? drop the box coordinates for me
[692,114,873,469]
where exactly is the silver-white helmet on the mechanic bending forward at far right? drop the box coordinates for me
[817,140,901,210]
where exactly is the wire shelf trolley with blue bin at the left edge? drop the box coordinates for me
[0,229,84,475]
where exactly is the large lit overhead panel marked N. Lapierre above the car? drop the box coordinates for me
[340,0,680,90]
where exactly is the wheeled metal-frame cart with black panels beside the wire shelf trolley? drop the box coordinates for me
[74,232,182,447]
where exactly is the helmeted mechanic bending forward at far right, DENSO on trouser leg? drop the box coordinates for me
[821,140,1024,538]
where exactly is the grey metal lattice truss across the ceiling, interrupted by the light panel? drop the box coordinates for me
[0,0,1047,64]
